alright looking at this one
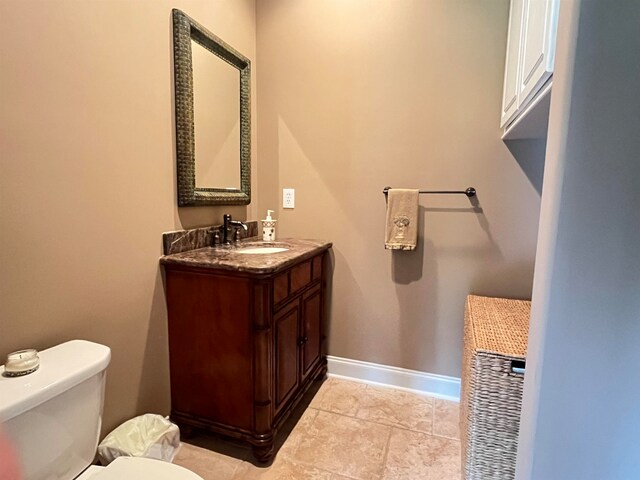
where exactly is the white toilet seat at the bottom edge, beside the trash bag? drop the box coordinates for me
[76,457,203,480]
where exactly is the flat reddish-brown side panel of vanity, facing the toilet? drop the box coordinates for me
[167,269,253,429]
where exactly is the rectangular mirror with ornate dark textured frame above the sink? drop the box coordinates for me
[172,9,251,207]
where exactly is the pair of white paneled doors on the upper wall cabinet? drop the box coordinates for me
[500,0,559,127]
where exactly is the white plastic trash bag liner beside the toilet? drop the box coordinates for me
[98,413,180,465]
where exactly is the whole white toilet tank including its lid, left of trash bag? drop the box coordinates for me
[0,340,111,480]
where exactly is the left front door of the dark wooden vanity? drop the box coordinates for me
[274,301,300,410]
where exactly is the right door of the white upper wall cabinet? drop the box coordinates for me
[518,0,558,106]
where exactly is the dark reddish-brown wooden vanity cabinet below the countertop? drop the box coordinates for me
[165,250,328,461]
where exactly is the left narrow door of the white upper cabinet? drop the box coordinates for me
[500,0,524,127]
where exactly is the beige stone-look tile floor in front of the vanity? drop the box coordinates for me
[174,378,461,480]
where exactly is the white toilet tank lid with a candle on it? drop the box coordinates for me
[0,340,111,422]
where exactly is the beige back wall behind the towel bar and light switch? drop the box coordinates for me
[257,0,544,376]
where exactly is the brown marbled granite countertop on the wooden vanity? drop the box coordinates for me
[160,237,332,274]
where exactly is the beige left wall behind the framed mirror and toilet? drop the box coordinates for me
[0,0,256,436]
